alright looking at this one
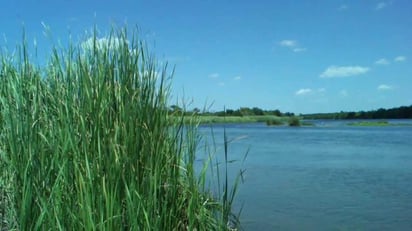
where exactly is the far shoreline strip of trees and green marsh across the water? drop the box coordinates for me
[168,105,412,126]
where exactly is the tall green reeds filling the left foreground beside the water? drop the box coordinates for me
[0,28,241,230]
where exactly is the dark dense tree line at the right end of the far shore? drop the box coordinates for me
[302,105,412,119]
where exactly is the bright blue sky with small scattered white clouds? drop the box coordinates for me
[0,0,412,113]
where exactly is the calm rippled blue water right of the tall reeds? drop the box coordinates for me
[201,121,412,230]
